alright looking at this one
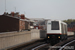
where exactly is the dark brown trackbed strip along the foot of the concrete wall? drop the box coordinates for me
[8,39,43,50]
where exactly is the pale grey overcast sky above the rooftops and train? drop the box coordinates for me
[0,0,75,20]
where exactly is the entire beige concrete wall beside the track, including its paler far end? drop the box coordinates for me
[0,29,46,50]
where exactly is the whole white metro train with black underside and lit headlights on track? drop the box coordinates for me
[46,20,67,43]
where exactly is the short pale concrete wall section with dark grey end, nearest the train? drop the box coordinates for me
[31,29,46,39]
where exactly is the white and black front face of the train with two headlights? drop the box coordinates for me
[47,21,61,43]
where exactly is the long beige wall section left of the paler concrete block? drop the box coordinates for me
[0,31,31,49]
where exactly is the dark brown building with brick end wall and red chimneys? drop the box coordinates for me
[0,12,30,32]
